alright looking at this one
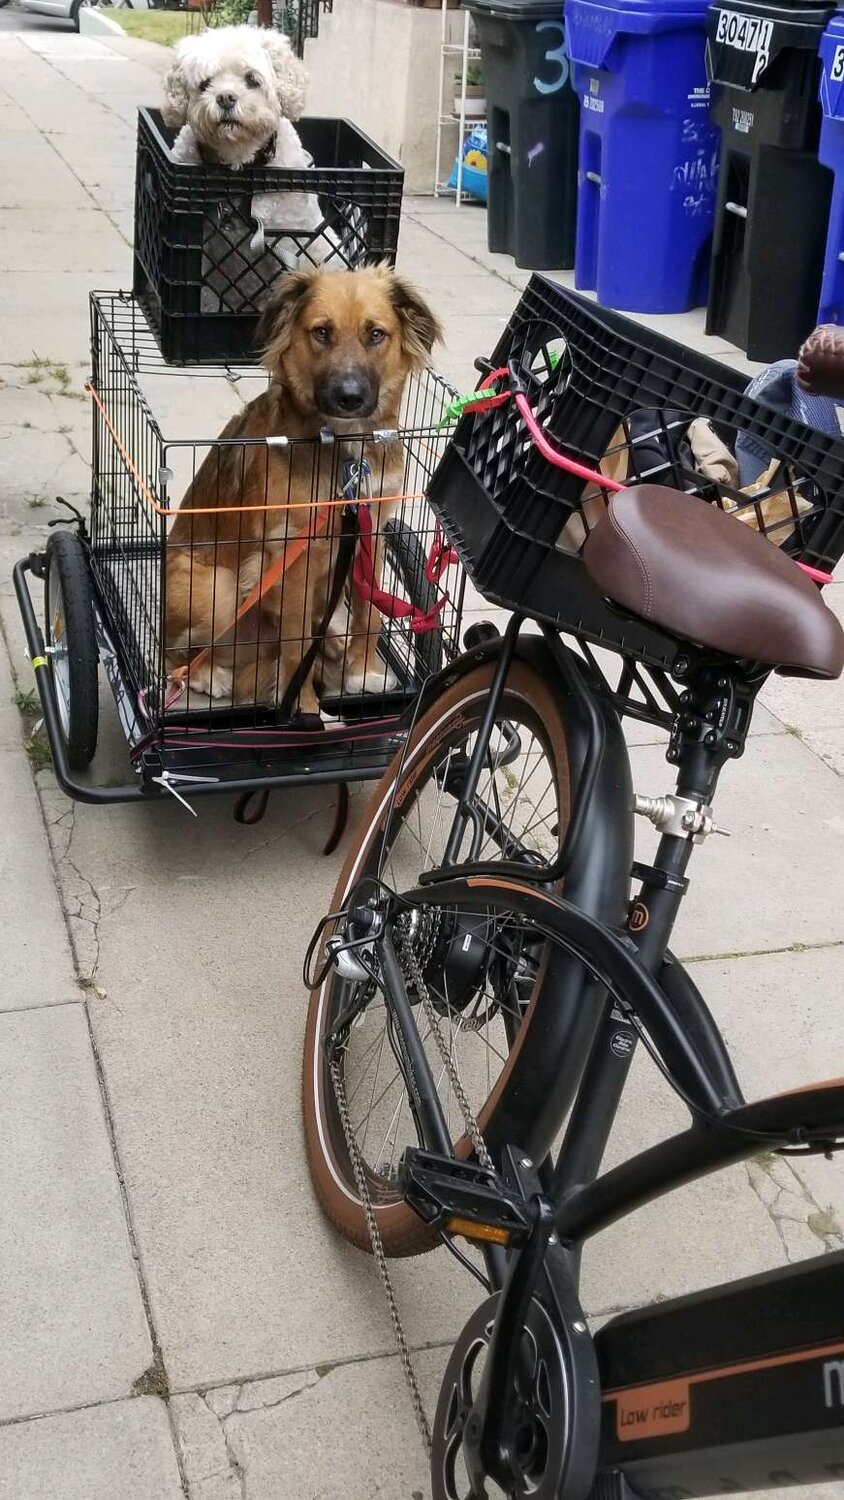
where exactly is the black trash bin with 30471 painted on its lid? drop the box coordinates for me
[706,0,835,363]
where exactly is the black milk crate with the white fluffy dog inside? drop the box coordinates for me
[133,110,405,365]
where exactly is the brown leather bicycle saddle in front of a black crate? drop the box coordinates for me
[583,485,844,678]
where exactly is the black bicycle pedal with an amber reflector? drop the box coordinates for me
[399,1146,535,1247]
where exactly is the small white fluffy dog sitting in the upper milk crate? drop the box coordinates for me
[162,26,343,295]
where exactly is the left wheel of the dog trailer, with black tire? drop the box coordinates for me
[43,531,99,771]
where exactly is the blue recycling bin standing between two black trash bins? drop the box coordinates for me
[565,0,720,312]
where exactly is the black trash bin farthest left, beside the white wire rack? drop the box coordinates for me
[466,0,580,270]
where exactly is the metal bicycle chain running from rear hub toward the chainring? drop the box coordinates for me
[330,924,493,1461]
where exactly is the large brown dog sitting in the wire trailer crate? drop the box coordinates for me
[166,266,441,714]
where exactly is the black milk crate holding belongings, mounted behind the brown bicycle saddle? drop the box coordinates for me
[429,276,844,671]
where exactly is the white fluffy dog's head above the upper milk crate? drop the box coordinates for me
[162,26,307,167]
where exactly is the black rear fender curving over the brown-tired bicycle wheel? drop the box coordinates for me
[417,621,633,1161]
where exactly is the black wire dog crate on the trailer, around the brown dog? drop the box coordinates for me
[87,293,465,789]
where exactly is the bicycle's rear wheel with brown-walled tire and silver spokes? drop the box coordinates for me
[304,662,570,1256]
